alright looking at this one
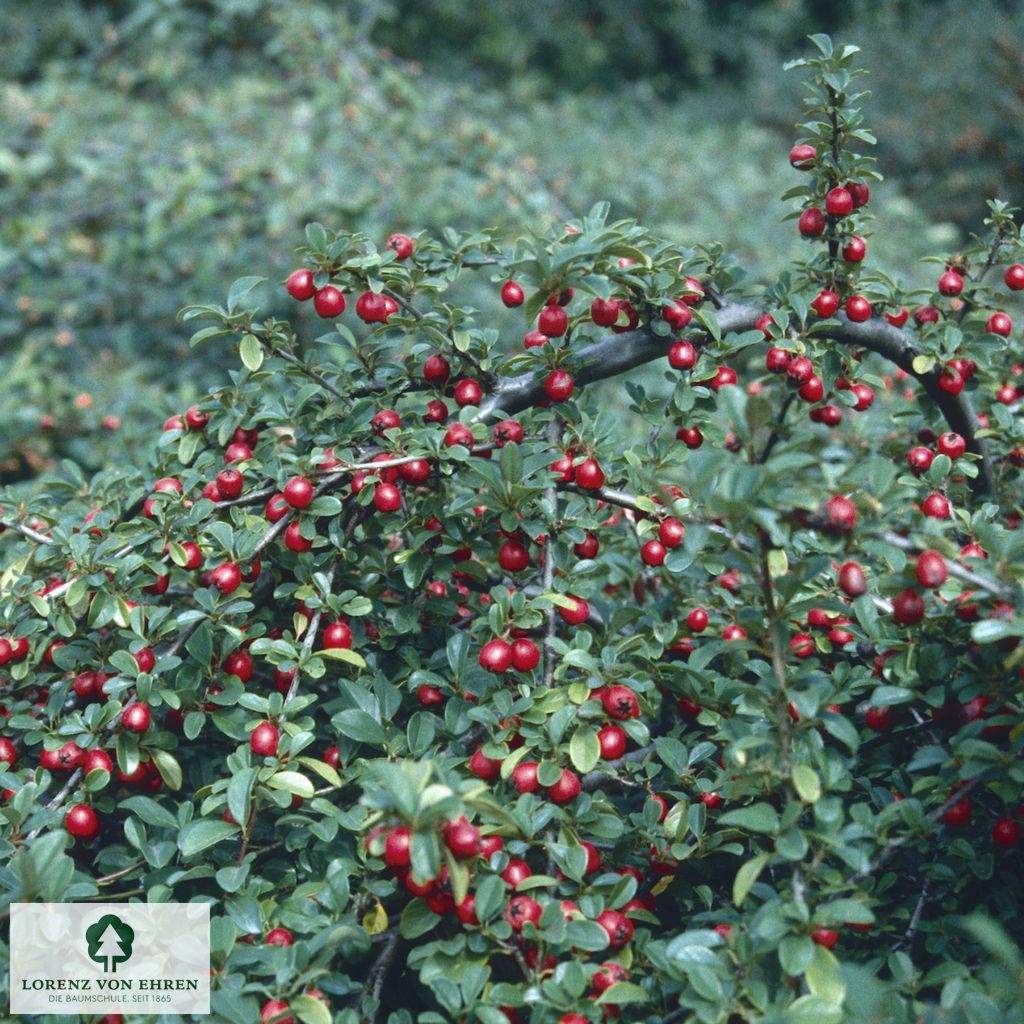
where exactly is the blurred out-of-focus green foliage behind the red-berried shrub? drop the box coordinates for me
[0,0,1024,482]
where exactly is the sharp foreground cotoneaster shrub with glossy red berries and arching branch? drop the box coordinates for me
[0,37,1024,1024]
